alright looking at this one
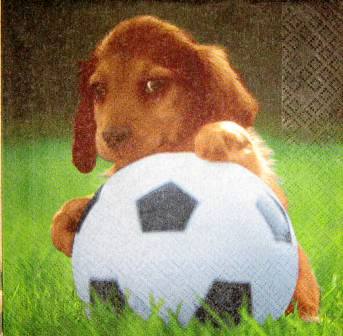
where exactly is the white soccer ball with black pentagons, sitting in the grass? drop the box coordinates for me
[72,153,298,324]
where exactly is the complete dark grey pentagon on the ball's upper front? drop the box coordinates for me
[136,182,198,232]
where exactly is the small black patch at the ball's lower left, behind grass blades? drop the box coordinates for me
[89,279,125,312]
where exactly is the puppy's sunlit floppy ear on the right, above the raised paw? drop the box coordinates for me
[198,45,258,127]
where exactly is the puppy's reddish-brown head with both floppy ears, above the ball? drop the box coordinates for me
[73,16,258,173]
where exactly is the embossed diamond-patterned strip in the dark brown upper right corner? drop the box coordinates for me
[281,1,343,142]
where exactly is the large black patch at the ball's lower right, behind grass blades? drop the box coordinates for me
[195,280,252,325]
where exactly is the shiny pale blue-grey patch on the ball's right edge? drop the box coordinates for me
[256,195,292,243]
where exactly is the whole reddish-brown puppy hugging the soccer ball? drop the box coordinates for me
[52,16,319,321]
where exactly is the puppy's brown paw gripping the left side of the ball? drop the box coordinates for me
[51,198,90,257]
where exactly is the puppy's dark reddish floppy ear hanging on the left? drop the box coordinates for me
[73,57,97,173]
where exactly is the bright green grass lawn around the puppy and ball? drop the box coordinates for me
[3,137,343,336]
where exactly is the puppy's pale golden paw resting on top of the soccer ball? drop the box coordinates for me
[194,121,260,174]
